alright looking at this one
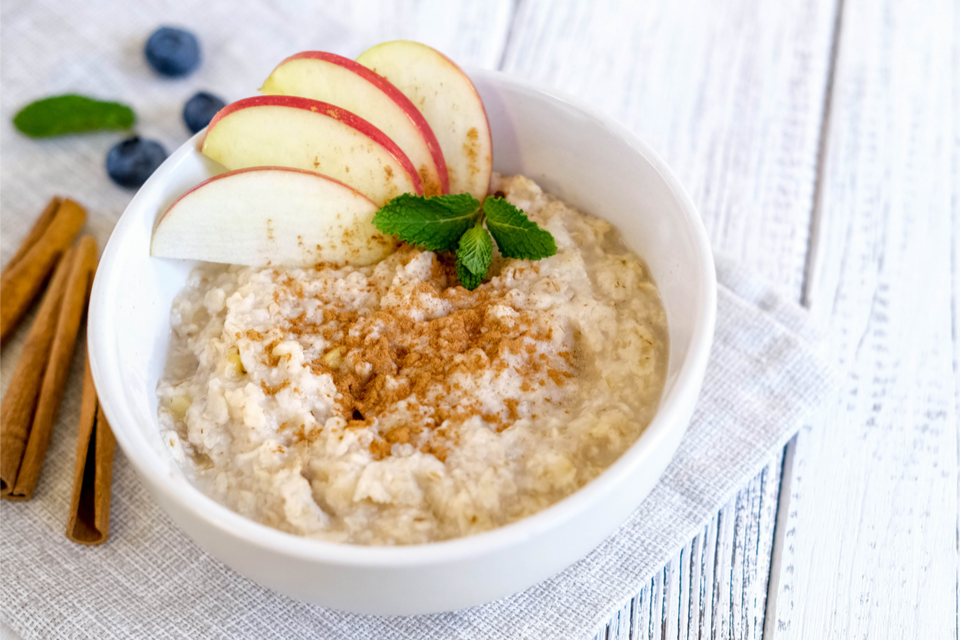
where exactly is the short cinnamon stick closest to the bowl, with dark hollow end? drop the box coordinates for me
[67,359,116,545]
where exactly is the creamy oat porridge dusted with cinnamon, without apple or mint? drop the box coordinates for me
[157,176,667,544]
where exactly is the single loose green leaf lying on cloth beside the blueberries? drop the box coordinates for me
[13,94,136,138]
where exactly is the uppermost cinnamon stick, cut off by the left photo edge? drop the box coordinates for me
[0,198,87,344]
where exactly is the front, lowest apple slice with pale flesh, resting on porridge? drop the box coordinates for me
[150,167,396,267]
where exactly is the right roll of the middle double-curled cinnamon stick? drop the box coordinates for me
[3,236,97,500]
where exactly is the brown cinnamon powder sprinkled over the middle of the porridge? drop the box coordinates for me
[245,248,576,462]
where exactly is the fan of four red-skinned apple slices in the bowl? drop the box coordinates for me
[151,40,493,266]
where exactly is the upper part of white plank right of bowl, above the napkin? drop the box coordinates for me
[504,0,834,299]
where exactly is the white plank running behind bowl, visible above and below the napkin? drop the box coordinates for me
[503,0,836,639]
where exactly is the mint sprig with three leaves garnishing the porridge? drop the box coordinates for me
[373,193,557,290]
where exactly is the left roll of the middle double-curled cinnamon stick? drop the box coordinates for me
[0,249,76,498]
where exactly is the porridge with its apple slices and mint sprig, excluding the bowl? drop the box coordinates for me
[151,41,668,545]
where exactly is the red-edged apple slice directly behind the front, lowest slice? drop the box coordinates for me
[200,96,423,207]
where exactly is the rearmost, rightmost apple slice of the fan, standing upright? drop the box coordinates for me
[357,40,493,200]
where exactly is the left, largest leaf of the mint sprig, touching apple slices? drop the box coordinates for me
[373,193,480,251]
